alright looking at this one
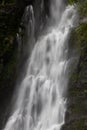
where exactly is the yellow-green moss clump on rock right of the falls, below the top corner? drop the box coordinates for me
[69,22,87,55]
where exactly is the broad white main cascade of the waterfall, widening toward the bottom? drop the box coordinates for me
[4,0,76,130]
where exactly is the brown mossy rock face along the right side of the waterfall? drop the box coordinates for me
[62,0,87,130]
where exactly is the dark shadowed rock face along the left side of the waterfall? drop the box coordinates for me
[0,0,49,129]
